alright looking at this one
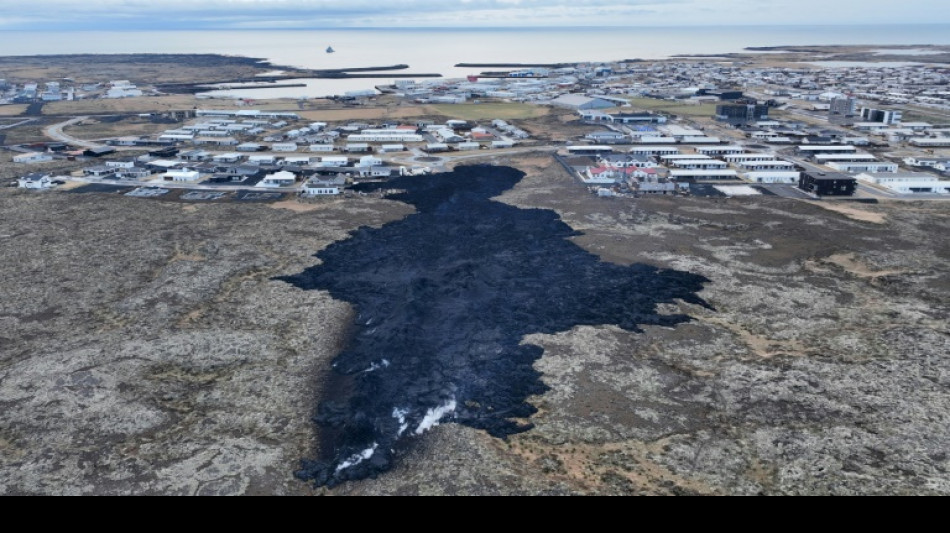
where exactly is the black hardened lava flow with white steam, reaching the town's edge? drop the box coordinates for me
[283,166,708,487]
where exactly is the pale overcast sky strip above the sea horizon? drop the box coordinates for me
[0,0,950,30]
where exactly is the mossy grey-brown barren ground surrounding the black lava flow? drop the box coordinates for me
[0,157,950,494]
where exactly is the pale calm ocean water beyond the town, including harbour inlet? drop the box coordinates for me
[0,24,950,98]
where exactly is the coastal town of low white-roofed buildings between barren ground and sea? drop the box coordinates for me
[0,56,950,200]
